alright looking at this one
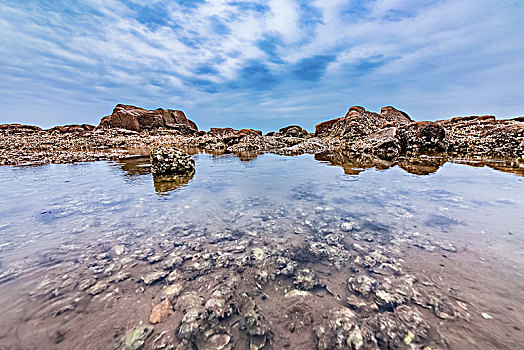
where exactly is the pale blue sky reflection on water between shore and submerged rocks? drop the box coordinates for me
[0,154,524,264]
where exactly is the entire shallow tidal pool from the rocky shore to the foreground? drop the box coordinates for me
[0,154,524,348]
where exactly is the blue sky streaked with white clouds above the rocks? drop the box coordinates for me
[0,0,524,131]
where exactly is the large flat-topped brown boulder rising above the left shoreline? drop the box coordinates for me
[98,104,198,135]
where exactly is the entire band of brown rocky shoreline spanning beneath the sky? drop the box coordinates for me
[0,105,524,165]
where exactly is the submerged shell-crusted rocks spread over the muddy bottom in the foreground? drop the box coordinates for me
[0,194,482,350]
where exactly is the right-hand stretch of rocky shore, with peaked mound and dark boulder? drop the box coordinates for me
[315,107,524,159]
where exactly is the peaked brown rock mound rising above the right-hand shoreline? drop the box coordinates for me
[315,106,412,139]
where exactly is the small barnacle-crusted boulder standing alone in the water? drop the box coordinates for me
[150,146,195,176]
